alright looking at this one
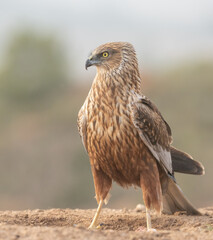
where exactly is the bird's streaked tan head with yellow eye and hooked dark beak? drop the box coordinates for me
[85,42,137,71]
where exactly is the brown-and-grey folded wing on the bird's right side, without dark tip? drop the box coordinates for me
[131,94,172,174]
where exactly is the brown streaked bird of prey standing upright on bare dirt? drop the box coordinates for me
[78,42,204,230]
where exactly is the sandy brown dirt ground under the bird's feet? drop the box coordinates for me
[0,207,213,240]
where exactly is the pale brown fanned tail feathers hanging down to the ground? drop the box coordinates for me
[163,177,201,215]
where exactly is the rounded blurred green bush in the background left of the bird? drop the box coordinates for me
[0,31,66,104]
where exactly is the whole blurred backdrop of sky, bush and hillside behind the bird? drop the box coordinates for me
[0,0,213,210]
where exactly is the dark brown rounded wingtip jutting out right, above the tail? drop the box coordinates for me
[171,147,205,175]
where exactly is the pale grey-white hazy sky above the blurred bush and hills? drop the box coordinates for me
[0,0,213,76]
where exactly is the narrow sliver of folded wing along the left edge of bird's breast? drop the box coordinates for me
[77,105,88,152]
